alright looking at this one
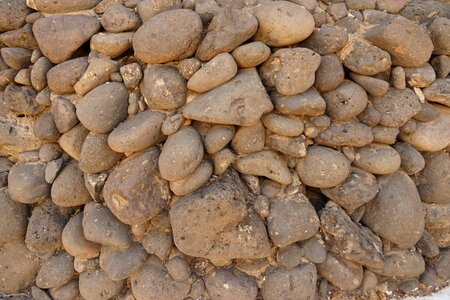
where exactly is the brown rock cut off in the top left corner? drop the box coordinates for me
[0,0,32,32]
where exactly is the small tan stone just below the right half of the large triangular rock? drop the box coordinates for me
[231,121,265,154]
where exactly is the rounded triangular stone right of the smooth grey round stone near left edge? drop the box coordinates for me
[51,161,91,207]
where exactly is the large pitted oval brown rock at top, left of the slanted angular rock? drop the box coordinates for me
[133,9,203,64]
